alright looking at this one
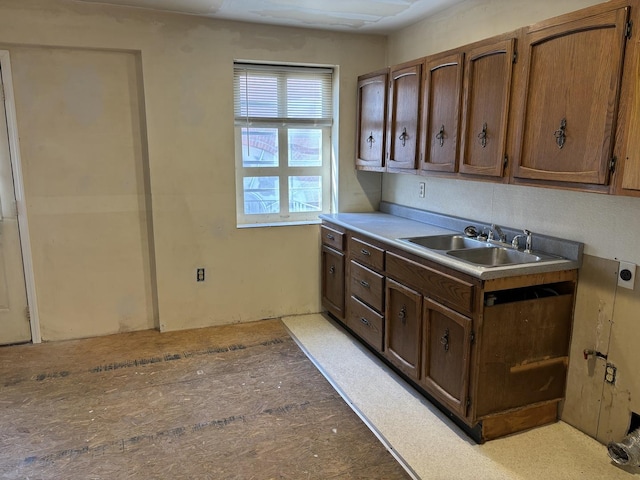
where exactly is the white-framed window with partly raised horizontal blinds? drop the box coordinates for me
[233,63,333,227]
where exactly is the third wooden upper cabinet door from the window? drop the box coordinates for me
[420,53,463,172]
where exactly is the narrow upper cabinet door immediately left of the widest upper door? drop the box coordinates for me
[459,39,515,177]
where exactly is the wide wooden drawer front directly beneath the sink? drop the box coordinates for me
[386,252,474,316]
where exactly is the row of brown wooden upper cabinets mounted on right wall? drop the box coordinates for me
[356,0,640,196]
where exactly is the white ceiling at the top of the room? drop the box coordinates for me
[78,0,464,34]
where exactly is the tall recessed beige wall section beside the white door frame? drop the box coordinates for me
[11,47,155,340]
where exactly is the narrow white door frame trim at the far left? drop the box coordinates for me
[0,50,42,343]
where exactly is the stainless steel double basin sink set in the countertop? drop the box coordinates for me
[399,234,560,267]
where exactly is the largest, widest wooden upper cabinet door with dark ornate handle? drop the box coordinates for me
[514,8,628,185]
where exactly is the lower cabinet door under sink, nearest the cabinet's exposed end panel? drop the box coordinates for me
[421,298,471,416]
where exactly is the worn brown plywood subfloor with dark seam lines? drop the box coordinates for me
[0,320,410,480]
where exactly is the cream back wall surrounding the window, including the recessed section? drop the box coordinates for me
[0,0,386,340]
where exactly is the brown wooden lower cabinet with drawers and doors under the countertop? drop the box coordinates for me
[322,221,577,442]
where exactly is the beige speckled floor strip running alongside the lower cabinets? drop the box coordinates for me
[283,315,640,480]
